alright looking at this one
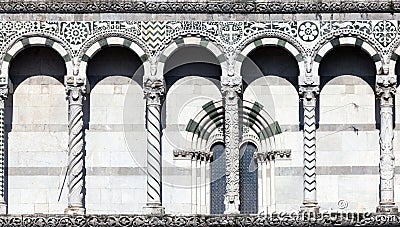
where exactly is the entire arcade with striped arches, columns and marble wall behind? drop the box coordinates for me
[0,15,400,224]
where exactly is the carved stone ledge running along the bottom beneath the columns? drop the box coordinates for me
[0,214,400,226]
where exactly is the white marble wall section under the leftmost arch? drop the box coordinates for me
[7,76,68,213]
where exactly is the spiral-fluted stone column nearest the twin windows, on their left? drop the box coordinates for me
[144,81,164,214]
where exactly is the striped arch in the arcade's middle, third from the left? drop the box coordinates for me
[157,37,228,78]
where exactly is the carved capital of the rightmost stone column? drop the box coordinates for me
[376,75,396,106]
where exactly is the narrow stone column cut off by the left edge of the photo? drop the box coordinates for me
[0,87,8,214]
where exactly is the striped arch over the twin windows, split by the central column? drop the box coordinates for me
[186,100,282,151]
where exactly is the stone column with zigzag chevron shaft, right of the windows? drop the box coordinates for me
[300,86,319,213]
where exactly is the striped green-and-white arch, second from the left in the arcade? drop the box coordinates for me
[79,34,150,82]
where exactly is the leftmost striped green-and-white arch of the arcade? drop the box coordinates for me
[0,35,73,85]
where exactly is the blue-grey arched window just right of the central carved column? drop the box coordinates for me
[239,143,258,214]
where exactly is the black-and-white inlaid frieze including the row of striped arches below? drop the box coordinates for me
[0,18,400,86]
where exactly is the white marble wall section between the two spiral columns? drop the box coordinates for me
[86,76,146,213]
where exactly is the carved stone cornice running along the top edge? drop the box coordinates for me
[0,0,400,14]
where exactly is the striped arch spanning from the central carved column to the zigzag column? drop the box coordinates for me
[235,37,305,79]
